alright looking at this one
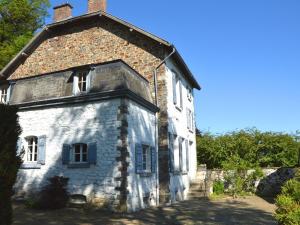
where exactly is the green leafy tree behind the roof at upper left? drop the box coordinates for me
[0,0,50,70]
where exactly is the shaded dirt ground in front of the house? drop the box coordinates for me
[14,196,276,225]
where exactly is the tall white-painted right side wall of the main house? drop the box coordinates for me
[166,60,197,201]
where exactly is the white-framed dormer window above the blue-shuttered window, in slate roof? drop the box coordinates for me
[73,71,90,95]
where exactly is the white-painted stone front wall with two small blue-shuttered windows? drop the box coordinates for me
[16,99,120,201]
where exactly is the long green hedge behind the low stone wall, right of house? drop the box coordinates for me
[197,129,300,169]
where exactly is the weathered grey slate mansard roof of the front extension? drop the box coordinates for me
[10,60,158,110]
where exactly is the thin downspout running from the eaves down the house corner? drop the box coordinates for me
[154,46,176,206]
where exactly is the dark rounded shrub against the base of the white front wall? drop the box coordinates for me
[34,176,69,209]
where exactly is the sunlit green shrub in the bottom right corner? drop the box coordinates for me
[275,173,300,225]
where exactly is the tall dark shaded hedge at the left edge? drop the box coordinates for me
[0,104,21,225]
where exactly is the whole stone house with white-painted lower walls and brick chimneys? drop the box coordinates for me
[0,0,200,211]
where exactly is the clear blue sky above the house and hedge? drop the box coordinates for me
[47,0,300,133]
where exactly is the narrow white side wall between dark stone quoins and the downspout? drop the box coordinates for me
[127,101,157,211]
